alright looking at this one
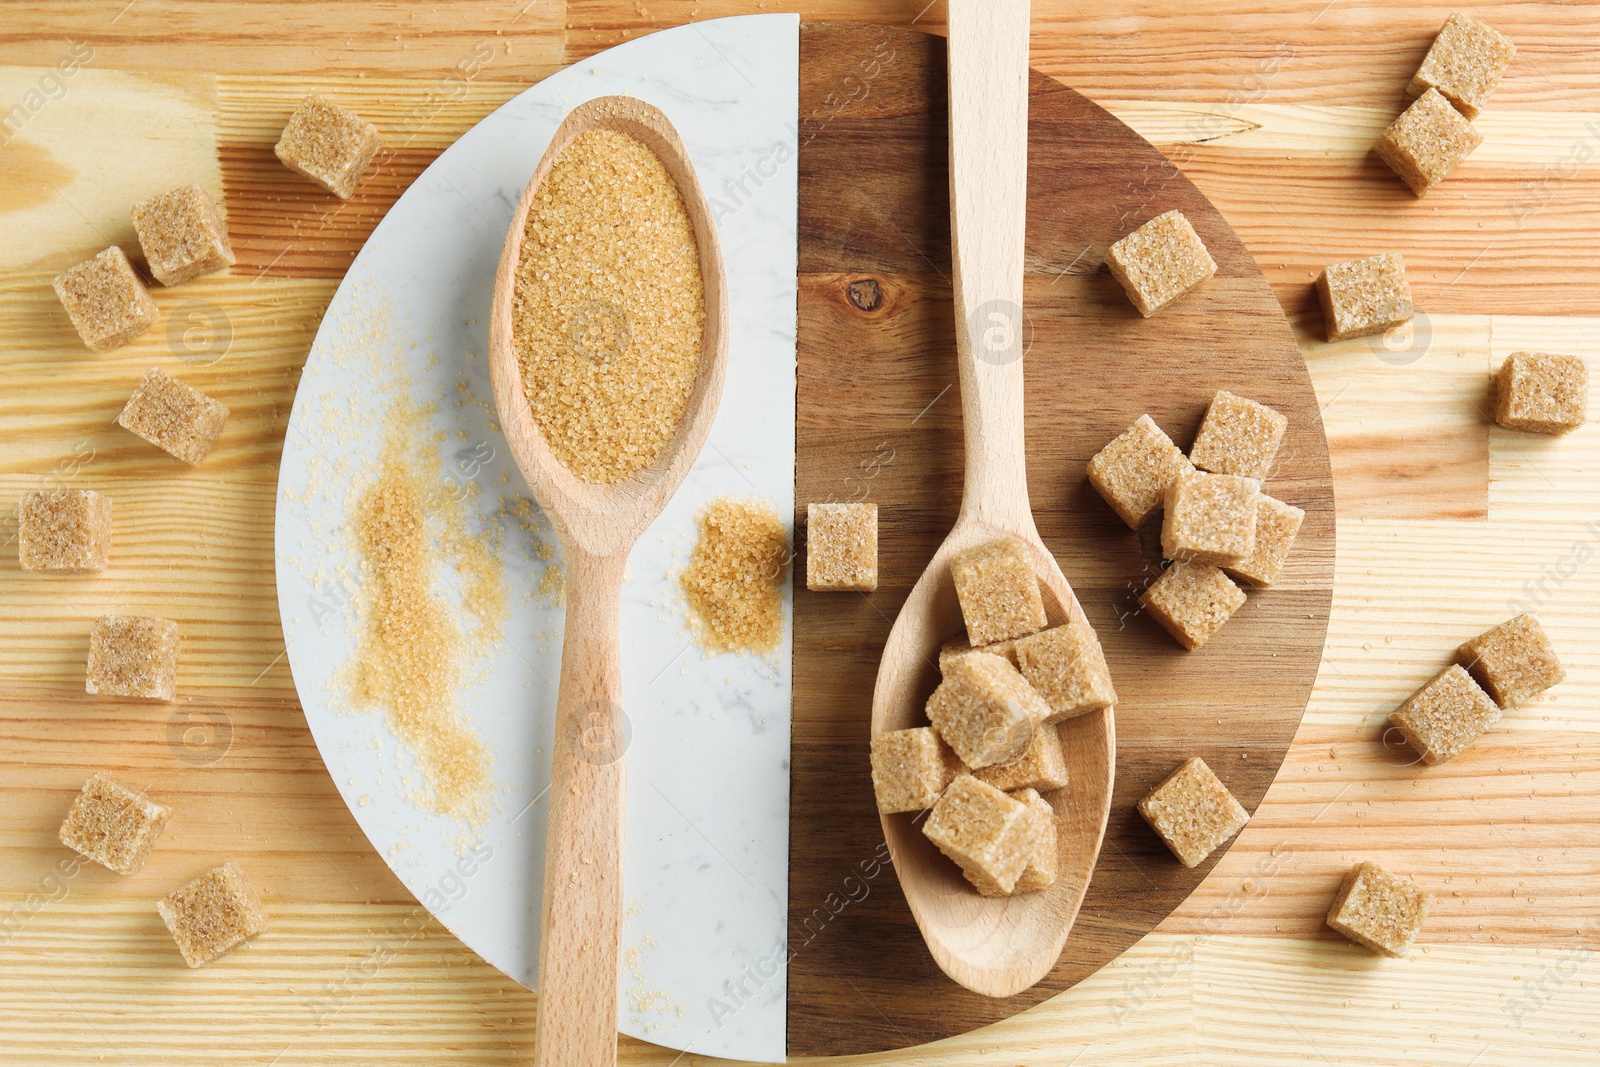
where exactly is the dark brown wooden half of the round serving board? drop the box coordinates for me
[789,24,1334,1056]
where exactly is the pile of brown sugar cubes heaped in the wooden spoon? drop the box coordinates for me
[872,537,1117,896]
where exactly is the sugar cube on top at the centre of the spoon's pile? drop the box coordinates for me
[928,656,1050,768]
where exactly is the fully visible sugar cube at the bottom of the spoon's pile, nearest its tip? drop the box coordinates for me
[922,774,1037,896]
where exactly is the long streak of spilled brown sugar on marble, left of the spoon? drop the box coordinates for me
[344,403,509,827]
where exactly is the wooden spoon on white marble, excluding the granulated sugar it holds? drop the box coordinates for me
[490,96,728,1067]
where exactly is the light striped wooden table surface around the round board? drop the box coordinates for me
[0,0,1600,1067]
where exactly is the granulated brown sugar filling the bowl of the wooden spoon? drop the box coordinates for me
[512,130,706,483]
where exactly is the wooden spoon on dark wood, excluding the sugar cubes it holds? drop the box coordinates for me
[872,0,1115,997]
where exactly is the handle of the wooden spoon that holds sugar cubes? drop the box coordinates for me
[949,0,1034,531]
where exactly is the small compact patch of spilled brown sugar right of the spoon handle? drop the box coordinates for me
[678,498,789,653]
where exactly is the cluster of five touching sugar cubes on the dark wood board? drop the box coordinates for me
[1088,390,1306,649]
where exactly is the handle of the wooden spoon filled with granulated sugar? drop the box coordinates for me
[533,544,627,1067]
